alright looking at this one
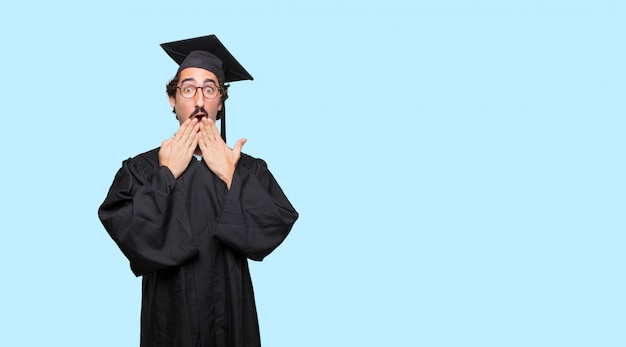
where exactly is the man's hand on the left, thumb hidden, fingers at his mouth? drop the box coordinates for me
[159,118,199,178]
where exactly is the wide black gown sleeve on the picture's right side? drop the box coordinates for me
[215,154,298,261]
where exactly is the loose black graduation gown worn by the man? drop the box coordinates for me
[98,148,298,347]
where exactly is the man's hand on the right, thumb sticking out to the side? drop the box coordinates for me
[198,118,247,189]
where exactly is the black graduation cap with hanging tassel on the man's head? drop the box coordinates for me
[161,35,253,142]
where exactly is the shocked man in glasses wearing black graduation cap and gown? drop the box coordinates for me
[98,35,298,347]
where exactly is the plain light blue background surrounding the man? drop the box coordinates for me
[0,0,626,347]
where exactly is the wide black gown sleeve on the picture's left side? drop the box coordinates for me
[98,155,198,276]
